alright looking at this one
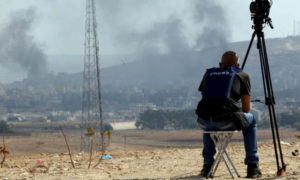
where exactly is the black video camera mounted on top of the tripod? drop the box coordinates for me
[250,0,272,19]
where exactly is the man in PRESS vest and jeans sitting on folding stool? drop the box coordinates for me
[196,51,261,178]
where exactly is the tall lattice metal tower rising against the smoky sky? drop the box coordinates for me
[80,0,104,151]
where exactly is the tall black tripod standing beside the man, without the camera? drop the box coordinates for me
[242,17,286,176]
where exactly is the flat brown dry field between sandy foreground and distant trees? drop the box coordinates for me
[2,130,300,156]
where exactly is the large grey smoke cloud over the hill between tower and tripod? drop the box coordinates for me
[98,0,231,90]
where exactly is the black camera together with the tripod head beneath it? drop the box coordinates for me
[250,0,274,32]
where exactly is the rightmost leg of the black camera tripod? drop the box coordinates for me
[262,33,286,171]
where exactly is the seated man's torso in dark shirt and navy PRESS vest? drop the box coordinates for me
[196,67,251,129]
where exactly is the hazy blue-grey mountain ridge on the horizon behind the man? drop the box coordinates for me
[8,37,300,94]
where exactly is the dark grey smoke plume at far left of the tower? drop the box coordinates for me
[0,8,47,79]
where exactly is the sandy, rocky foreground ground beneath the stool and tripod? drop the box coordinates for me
[0,140,300,180]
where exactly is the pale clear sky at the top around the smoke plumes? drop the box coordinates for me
[0,0,300,54]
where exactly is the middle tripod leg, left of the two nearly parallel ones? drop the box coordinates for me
[257,33,281,172]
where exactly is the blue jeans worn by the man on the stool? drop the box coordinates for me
[197,113,259,164]
